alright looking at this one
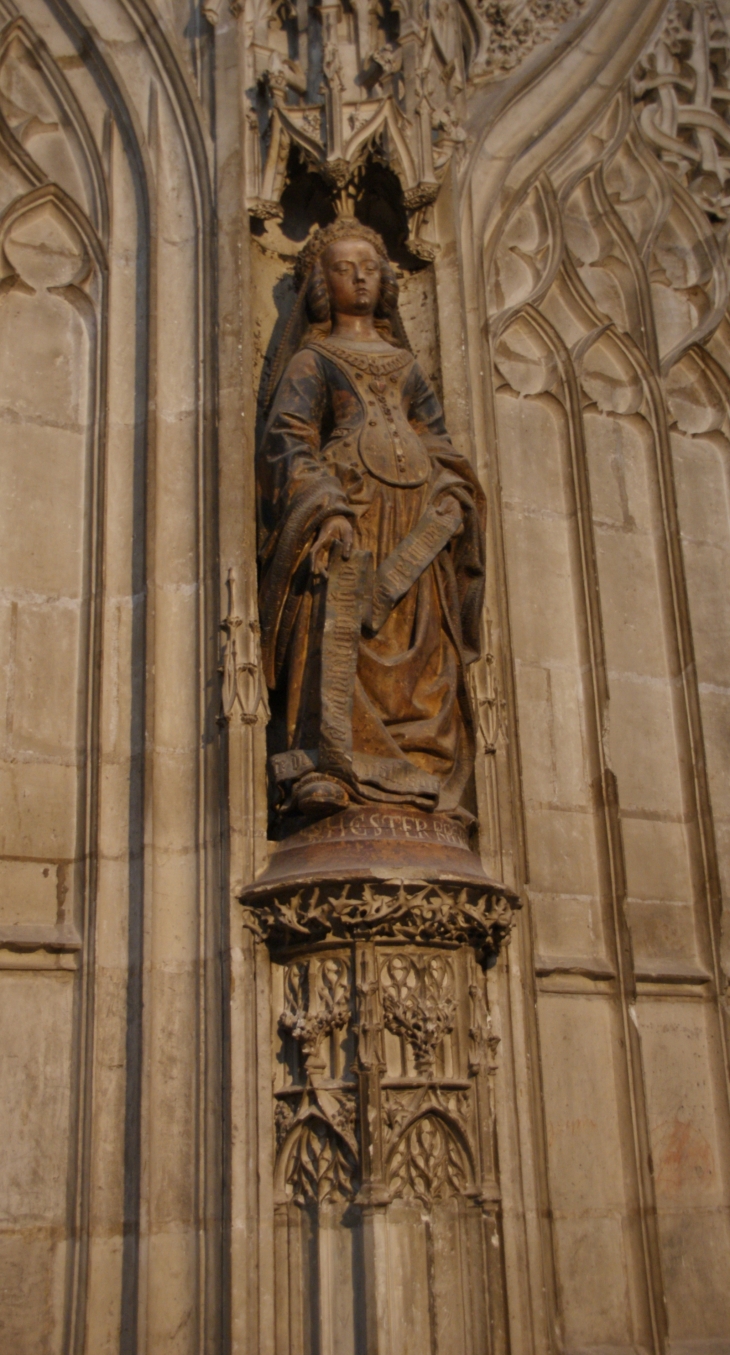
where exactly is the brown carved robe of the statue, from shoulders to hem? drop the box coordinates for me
[257,331,485,812]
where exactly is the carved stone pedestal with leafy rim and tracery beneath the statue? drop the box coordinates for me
[242,808,517,1355]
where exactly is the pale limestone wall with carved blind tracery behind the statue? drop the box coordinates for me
[0,0,730,1355]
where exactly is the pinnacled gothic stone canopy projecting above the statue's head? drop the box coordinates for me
[239,0,466,259]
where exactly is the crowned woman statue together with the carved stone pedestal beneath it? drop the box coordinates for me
[241,203,517,1352]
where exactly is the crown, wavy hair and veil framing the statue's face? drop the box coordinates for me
[265,217,410,409]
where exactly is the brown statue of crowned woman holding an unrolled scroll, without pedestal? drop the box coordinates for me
[256,218,485,831]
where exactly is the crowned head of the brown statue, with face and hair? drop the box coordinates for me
[299,217,398,324]
